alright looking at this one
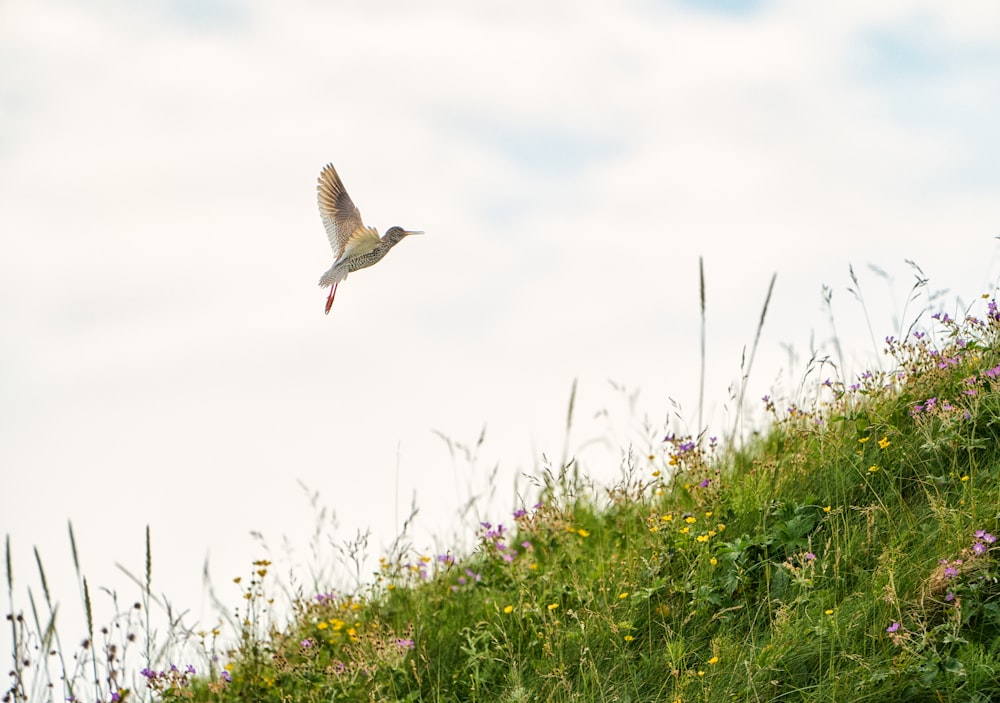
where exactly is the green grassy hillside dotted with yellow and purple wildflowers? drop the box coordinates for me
[8,294,1000,703]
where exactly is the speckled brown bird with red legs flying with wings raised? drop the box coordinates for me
[316,164,423,315]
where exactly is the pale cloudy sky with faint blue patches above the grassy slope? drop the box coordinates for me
[0,0,1000,664]
